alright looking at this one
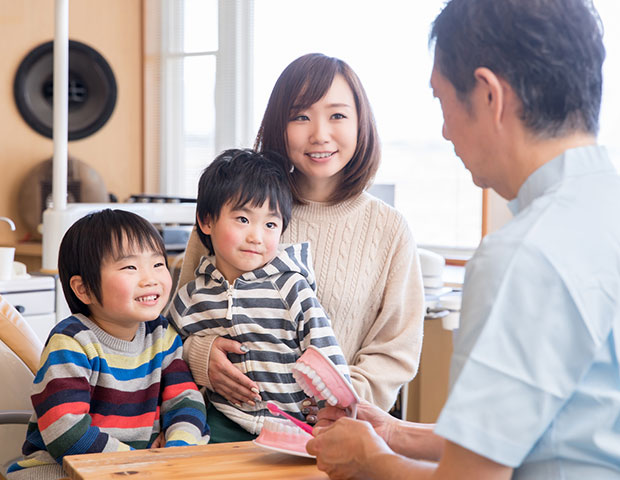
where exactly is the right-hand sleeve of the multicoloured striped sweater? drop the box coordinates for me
[161,328,209,447]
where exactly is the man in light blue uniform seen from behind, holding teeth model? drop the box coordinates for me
[308,0,620,480]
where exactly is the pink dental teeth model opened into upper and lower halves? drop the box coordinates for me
[254,346,360,457]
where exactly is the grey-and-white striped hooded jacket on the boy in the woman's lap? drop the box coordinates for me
[168,243,349,434]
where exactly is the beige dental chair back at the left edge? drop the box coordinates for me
[0,295,43,478]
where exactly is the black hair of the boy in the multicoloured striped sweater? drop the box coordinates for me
[58,208,168,316]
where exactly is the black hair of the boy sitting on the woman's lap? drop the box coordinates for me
[196,149,293,255]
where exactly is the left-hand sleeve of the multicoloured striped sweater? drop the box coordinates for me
[31,333,132,464]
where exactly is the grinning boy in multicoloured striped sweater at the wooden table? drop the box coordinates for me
[7,209,209,480]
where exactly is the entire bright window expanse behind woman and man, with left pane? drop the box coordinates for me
[147,0,620,249]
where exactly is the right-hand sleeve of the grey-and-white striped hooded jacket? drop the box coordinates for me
[286,274,351,380]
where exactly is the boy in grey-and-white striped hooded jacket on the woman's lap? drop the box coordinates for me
[168,150,349,443]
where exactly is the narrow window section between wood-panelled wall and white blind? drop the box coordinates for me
[145,0,219,197]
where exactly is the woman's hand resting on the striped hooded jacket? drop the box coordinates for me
[209,337,261,405]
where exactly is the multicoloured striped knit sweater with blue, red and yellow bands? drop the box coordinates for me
[8,314,209,478]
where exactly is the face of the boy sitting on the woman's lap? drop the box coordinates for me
[199,201,282,283]
